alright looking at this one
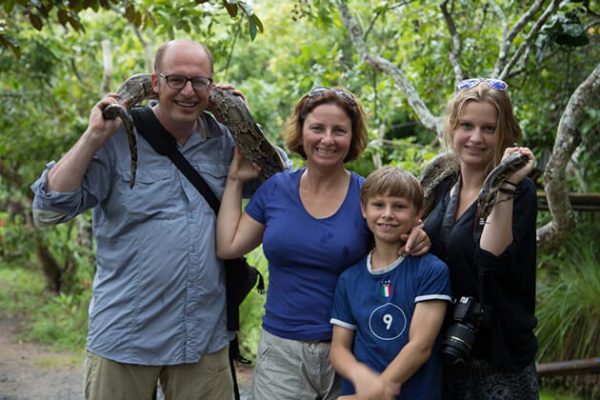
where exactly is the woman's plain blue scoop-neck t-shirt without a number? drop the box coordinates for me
[245,169,371,340]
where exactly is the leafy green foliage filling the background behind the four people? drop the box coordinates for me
[0,0,600,390]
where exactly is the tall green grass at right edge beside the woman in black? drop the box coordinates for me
[536,223,600,398]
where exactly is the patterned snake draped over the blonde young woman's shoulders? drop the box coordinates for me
[419,152,527,220]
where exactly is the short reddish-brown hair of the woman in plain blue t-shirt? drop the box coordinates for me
[283,88,367,162]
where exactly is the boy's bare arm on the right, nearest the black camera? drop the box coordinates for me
[382,300,447,384]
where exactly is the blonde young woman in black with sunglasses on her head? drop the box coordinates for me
[425,78,538,400]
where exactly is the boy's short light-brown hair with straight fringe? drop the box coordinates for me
[360,167,423,212]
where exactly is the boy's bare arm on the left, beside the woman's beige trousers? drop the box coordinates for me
[330,325,400,400]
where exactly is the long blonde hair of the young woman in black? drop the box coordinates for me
[444,83,521,170]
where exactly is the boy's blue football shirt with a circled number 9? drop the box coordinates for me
[331,254,450,400]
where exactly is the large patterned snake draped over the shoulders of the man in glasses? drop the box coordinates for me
[102,74,285,187]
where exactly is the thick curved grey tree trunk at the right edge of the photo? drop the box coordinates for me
[537,64,600,247]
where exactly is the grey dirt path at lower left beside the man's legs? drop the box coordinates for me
[0,319,252,400]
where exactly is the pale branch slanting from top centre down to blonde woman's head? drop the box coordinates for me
[337,0,442,138]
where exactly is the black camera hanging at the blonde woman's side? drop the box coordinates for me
[442,297,484,366]
